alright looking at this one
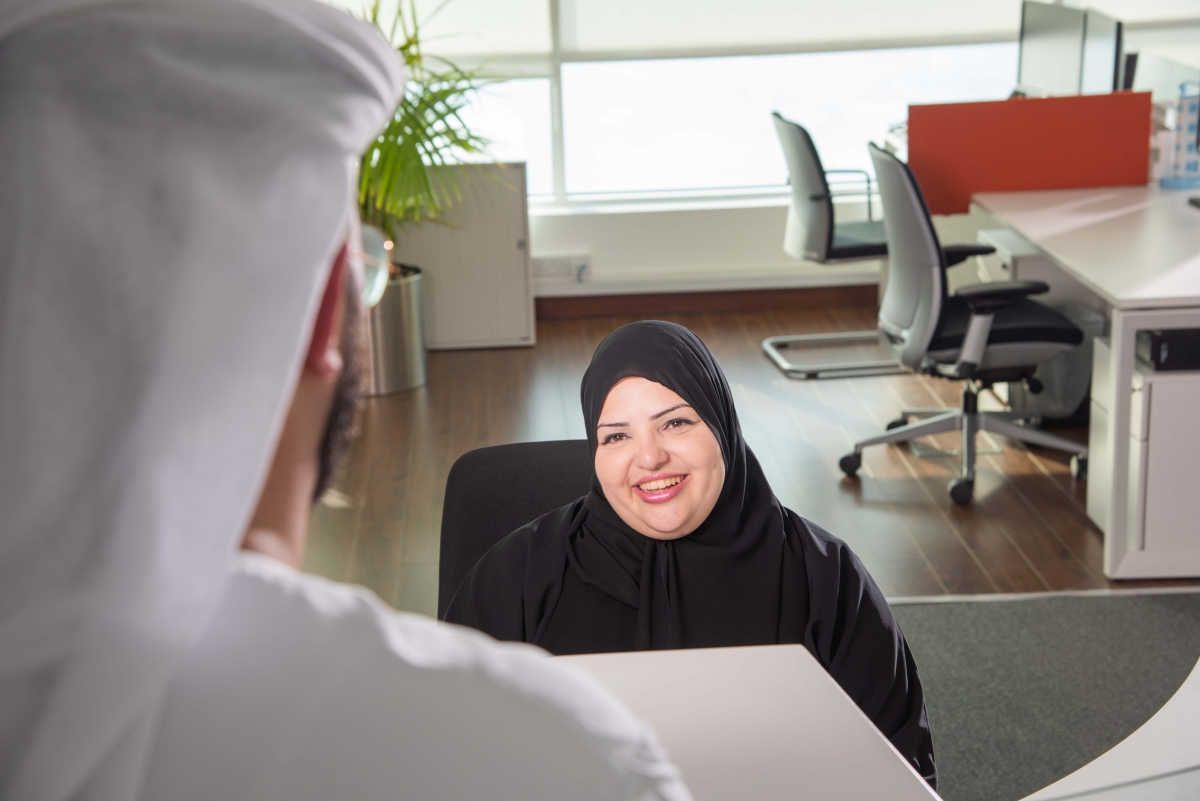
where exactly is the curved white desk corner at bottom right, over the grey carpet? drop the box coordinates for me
[1025,663,1200,801]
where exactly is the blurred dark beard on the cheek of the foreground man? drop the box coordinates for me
[312,275,366,502]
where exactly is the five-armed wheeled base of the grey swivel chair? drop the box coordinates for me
[839,381,1087,504]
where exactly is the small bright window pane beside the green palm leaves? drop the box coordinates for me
[462,78,554,195]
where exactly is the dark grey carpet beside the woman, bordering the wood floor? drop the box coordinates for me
[894,594,1200,801]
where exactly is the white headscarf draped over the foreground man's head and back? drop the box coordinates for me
[0,0,401,801]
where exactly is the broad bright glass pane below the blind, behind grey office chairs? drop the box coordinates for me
[563,42,1018,194]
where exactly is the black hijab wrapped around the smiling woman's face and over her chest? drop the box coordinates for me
[566,321,808,650]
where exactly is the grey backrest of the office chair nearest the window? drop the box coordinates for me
[770,112,833,261]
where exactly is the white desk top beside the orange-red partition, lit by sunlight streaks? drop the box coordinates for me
[972,186,1200,309]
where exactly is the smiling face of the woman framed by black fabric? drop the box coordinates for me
[595,378,725,540]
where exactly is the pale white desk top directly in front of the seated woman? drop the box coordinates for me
[558,645,937,801]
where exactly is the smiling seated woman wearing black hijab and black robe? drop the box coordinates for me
[446,321,937,788]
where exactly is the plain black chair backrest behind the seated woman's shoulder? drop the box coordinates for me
[438,440,593,620]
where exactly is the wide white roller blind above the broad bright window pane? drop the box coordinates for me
[558,0,1021,55]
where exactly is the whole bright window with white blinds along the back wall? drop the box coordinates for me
[329,0,1196,203]
